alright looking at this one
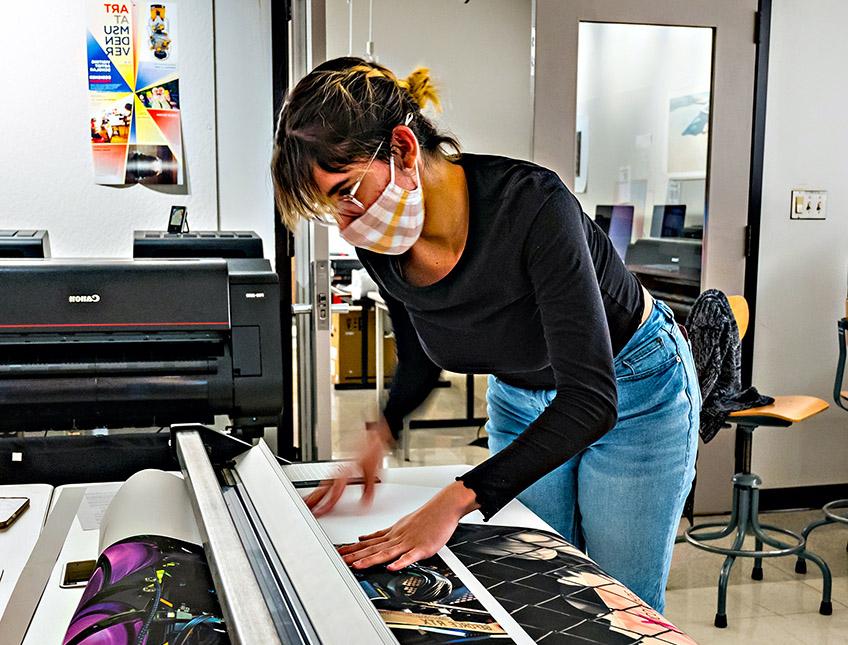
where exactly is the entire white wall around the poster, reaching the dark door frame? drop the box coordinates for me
[0,0,273,257]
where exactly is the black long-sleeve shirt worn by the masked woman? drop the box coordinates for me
[358,154,644,519]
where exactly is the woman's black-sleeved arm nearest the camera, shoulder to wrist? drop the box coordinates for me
[460,184,618,519]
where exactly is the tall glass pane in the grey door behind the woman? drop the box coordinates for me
[574,22,714,323]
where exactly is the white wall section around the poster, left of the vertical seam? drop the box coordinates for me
[0,0,217,257]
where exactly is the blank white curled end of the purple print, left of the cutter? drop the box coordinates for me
[100,470,202,552]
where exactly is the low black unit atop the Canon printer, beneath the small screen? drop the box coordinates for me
[133,231,264,258]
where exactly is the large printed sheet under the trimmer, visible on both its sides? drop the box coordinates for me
[63,470,694,645]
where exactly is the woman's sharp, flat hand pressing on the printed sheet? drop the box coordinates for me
[339,482,479,571]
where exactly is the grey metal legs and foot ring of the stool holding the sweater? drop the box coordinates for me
[684,425,832,628]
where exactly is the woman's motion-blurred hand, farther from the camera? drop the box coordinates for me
[306,417,394,517]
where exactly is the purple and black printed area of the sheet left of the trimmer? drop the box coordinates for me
[62,535,230,645]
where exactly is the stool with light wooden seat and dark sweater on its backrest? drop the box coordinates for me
[684,296,833,628]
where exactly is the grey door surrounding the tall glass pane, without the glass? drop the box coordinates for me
[533,0,771,512]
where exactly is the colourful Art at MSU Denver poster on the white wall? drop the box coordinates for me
[87,0,183,185]
